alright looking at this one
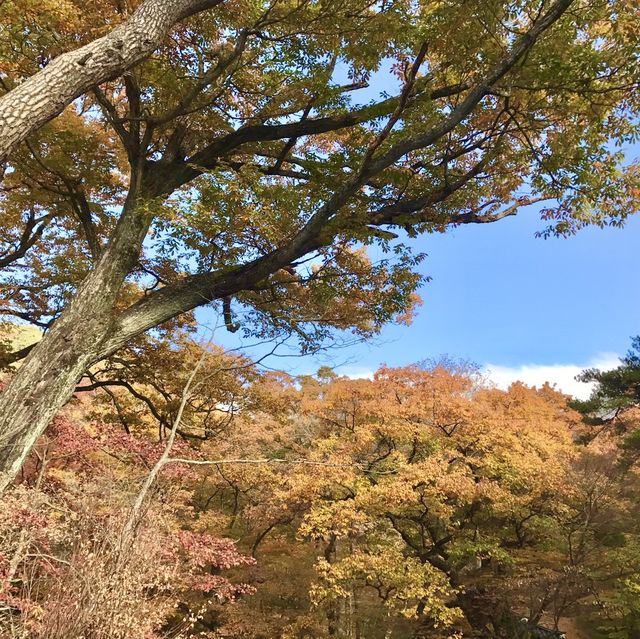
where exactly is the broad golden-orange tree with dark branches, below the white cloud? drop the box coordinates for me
[204,363,584,637]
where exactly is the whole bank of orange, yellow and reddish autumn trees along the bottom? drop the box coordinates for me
[0,338,640,639]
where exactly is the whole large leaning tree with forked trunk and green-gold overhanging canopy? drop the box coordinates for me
[0,0,637,488]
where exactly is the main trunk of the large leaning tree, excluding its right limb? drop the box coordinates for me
[0,195,149,494]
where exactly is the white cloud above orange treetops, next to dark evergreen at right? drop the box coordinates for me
[484,353,620,399]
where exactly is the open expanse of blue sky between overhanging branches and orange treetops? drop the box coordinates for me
[363,205,640,366]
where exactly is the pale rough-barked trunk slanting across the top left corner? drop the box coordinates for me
[0,0,222,162]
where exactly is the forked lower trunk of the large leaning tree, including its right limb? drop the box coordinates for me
[0,178,320,494]
